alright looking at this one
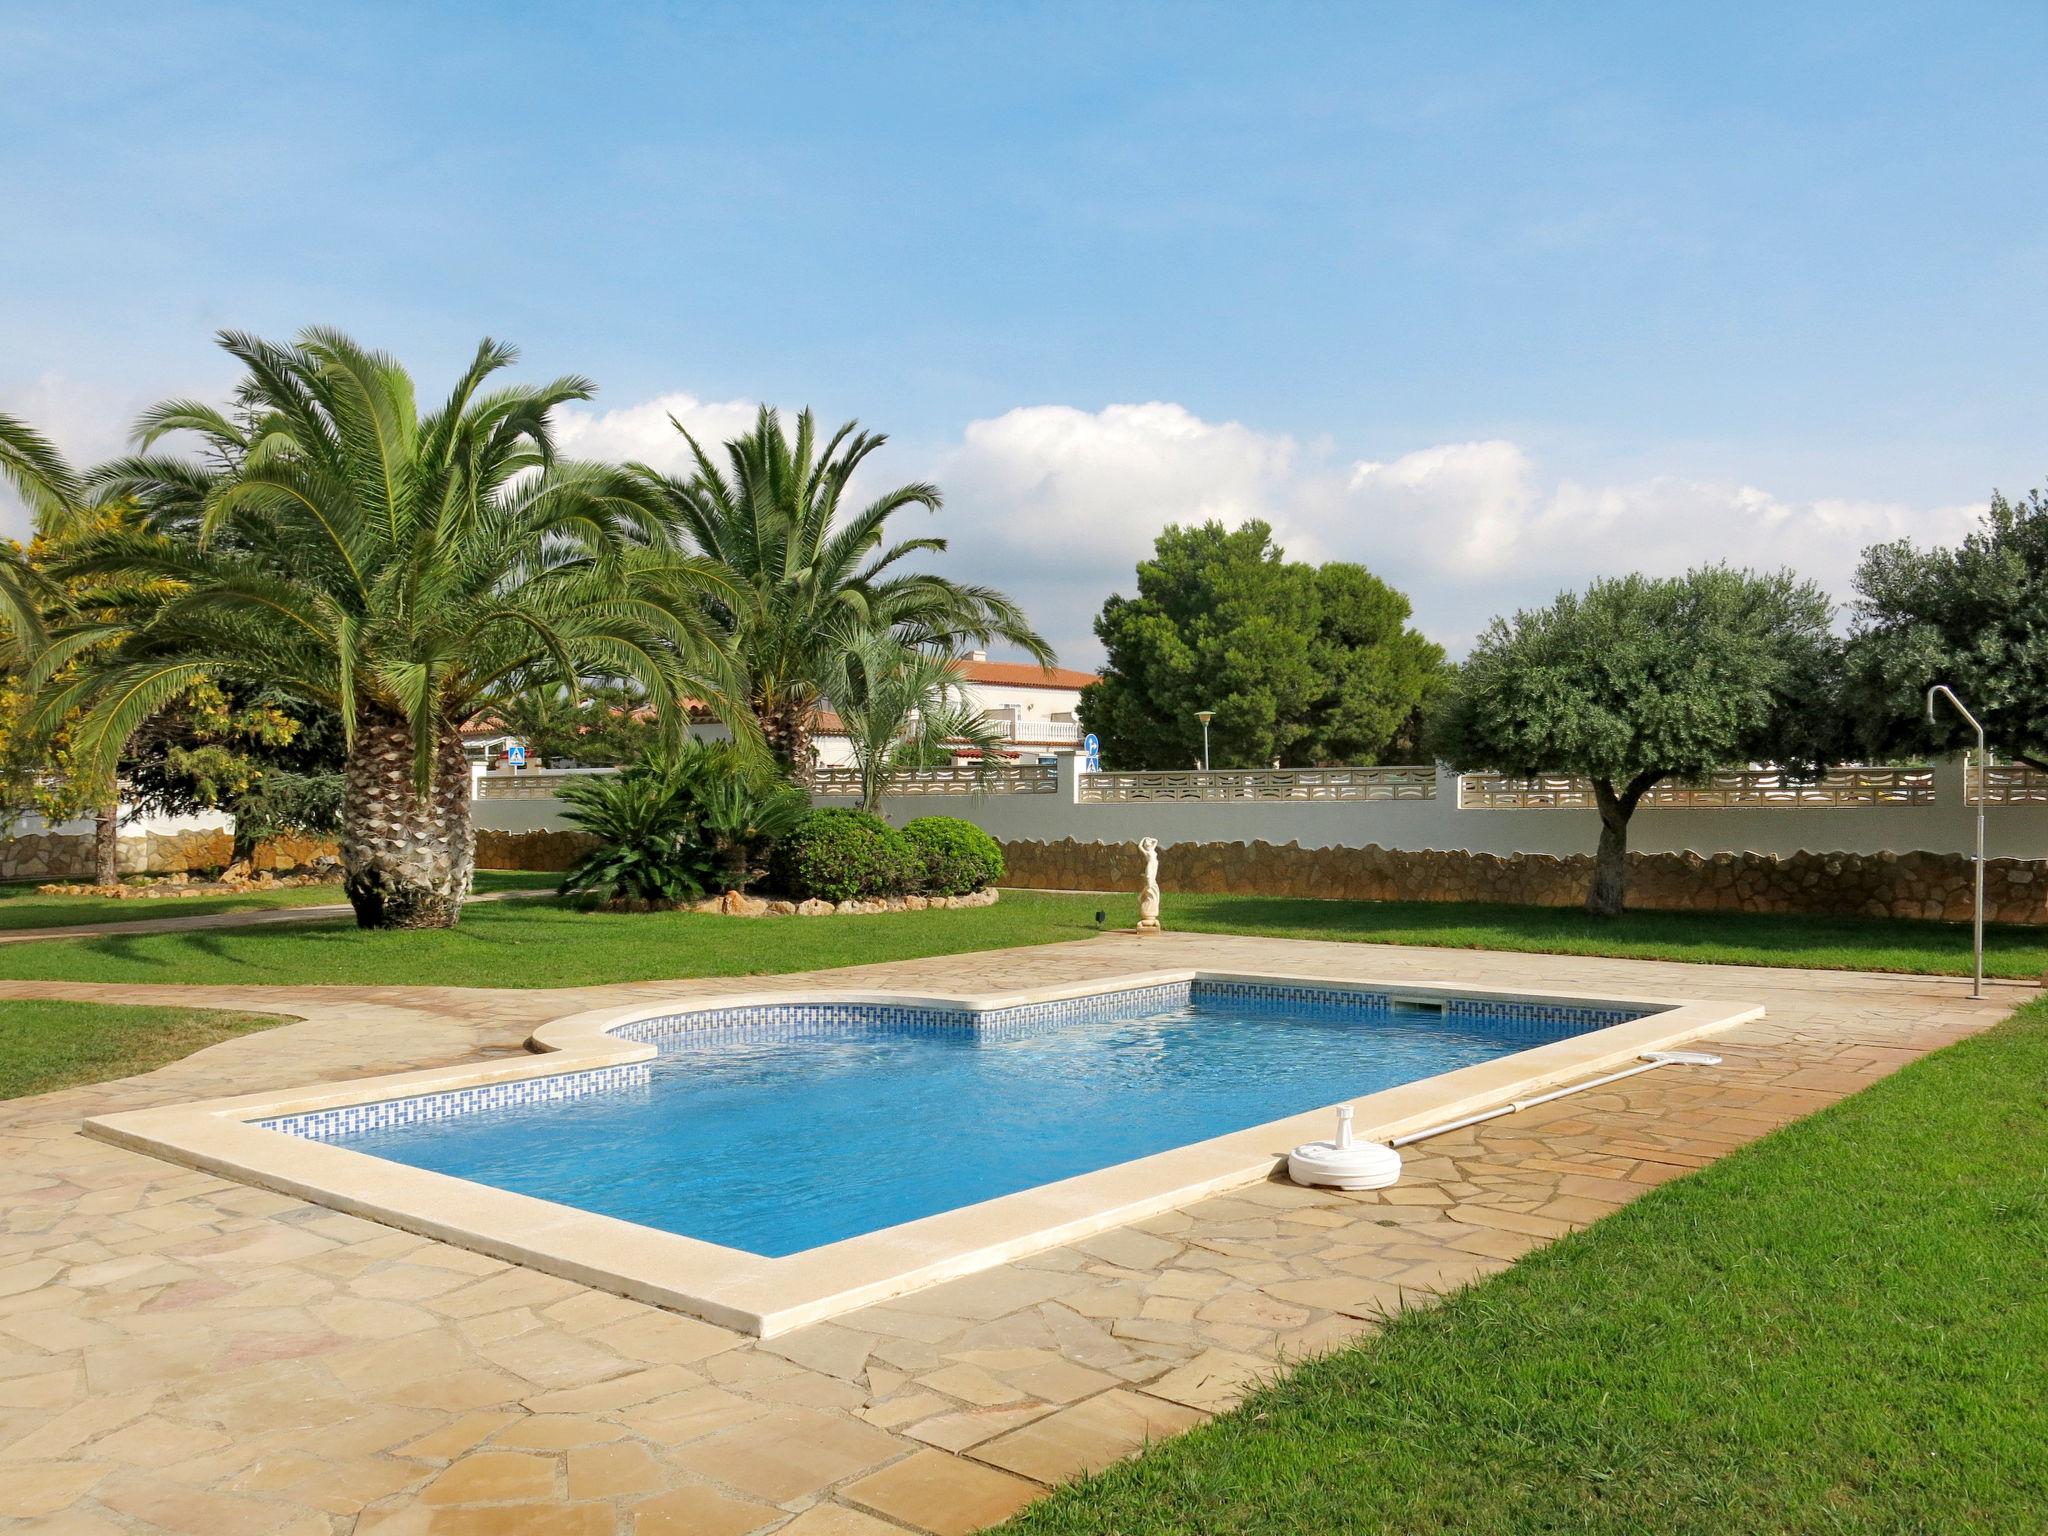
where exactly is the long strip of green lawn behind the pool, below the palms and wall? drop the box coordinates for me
[0,877,2023,987]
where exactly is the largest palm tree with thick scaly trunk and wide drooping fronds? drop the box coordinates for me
[39,330,733,928]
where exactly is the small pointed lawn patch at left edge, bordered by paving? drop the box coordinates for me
[0,1001,285,1100]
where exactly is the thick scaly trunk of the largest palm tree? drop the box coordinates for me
[342,715,477,928]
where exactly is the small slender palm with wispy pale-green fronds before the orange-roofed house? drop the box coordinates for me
[831,631,1004,815]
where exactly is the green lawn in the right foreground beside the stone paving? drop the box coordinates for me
[1004,1004,2048,1536]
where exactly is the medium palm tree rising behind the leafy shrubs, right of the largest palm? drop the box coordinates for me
[629,408,1053,772]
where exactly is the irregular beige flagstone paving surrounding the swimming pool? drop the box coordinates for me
[0,936,2034,1536]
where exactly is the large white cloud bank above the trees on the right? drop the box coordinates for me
[938,403,1978,662]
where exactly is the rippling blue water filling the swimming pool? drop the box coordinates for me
[288,983,1630,1257]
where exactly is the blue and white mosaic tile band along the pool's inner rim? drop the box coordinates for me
[256,981,1640,1141]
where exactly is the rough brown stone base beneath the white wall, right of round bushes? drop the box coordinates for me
[1004,838,2048,924]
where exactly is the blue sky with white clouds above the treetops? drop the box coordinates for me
[0,0,2048,662]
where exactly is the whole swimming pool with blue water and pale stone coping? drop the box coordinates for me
[84,974,1763,1337]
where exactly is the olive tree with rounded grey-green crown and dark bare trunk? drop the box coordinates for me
[1432,565,1841,918]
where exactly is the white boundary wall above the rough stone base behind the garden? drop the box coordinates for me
[471,758,2048,858]
